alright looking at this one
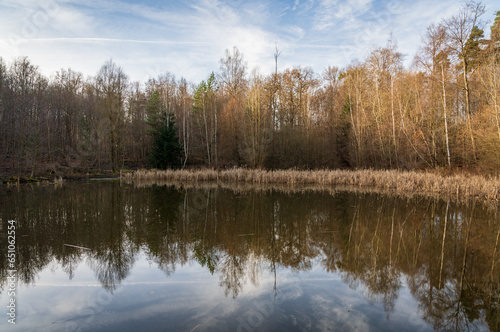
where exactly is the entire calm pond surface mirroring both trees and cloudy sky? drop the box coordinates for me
[0,181,500,332]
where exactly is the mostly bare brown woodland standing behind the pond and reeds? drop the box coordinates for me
[0,2,500,175]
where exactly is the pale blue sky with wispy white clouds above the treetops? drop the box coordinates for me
[0,0,500,83]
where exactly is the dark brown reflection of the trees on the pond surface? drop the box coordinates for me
[0,182,500,331]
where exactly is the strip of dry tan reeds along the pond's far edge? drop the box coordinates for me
[121,168,500,201]
